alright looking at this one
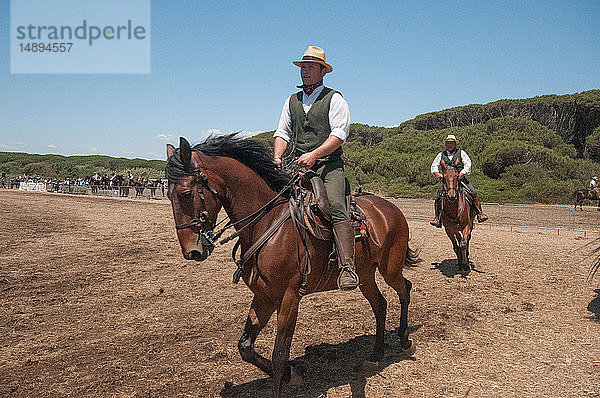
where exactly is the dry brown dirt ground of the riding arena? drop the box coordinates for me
[0,190,600,398]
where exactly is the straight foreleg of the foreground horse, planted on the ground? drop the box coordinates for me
[272,288,300,398]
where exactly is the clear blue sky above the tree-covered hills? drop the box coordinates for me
[0,0,600,159]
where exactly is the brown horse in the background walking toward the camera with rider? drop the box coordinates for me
[440,161,475,275]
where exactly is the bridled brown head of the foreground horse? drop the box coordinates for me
[166,137,222,261]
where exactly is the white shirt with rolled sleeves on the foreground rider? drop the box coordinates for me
[273,86,350,142]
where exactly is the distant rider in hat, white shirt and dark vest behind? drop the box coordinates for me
[430,134,488,228]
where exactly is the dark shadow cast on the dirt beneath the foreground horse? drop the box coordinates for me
[220,325,421,398]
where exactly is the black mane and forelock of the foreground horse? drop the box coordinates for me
[165,133,290,192]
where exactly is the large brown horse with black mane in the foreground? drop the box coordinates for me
[166,134,419,397]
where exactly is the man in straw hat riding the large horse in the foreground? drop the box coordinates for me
[273,46,358,290]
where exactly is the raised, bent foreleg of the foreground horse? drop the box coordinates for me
[238,297,275,376]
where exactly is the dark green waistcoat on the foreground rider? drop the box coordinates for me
[290,87,342,162]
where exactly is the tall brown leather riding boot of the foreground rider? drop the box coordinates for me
[333,220,358,290]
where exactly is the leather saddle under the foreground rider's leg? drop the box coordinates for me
[295,170,369,241]
